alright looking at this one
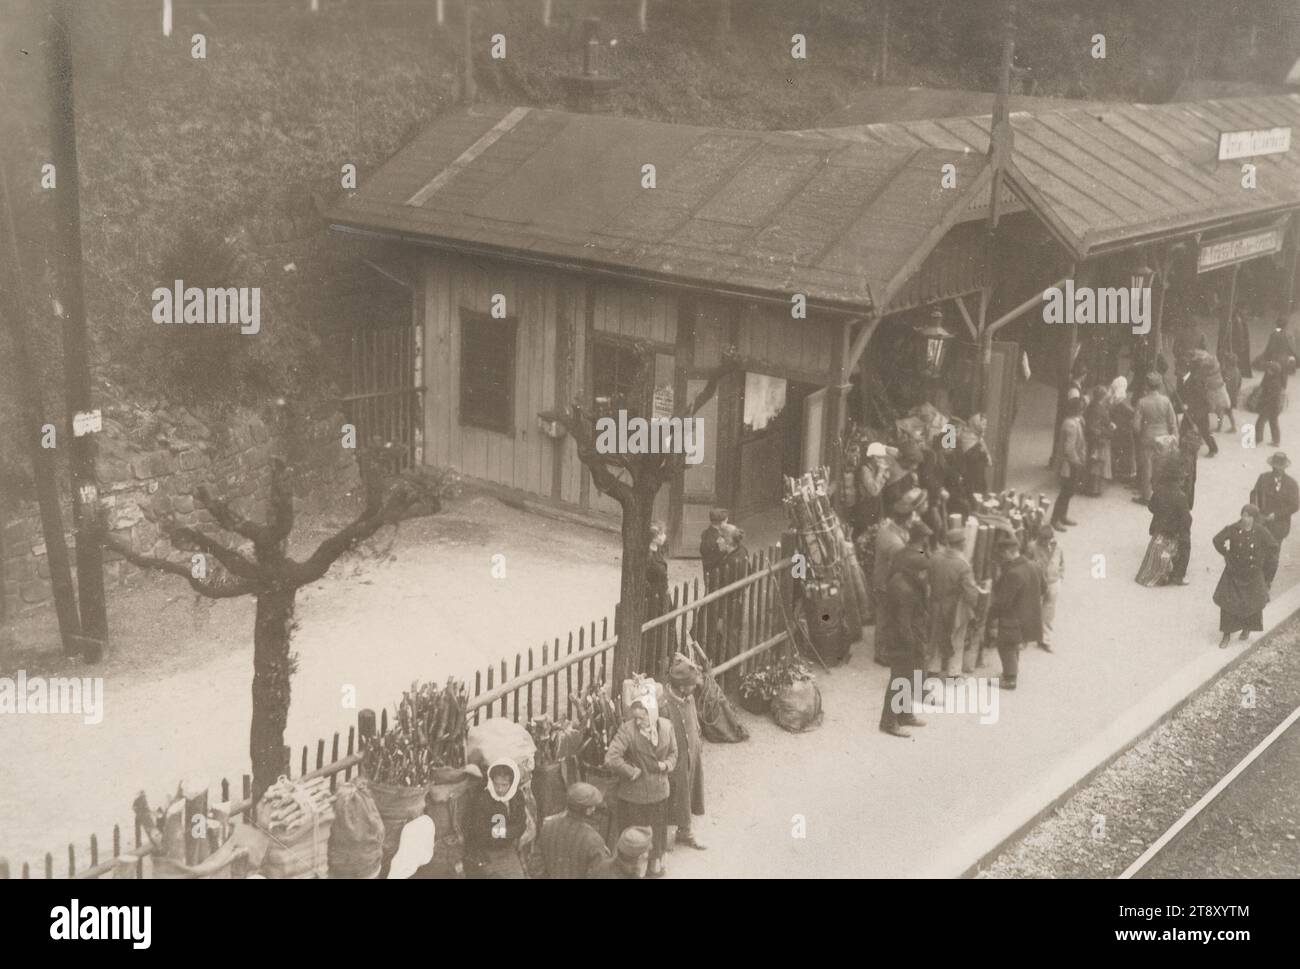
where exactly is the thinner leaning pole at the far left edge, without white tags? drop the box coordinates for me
[0,160,81,656]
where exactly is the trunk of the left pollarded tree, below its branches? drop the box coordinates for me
[248,589,296,801]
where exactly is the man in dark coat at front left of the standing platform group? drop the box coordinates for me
[878,522,931,737]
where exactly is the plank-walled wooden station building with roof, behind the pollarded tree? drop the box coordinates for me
[329,107,989,554]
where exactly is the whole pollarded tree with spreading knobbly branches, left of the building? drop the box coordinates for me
[100,439,441,800]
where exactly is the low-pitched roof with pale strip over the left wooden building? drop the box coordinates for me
[328,107,987,311]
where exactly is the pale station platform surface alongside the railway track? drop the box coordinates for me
[668,313,1300,877]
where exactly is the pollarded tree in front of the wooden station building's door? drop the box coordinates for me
[541,341,737,684]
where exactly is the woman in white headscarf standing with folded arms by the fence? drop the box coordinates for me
[605,693,677,878]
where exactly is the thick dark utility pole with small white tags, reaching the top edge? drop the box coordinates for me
[48,0,108,662]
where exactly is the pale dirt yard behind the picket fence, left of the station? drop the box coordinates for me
[0,497,698,871]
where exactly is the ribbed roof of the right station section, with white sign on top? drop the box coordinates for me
[806,94,1300,258]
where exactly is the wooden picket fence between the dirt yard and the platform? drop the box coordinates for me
[0,546,792,879]
